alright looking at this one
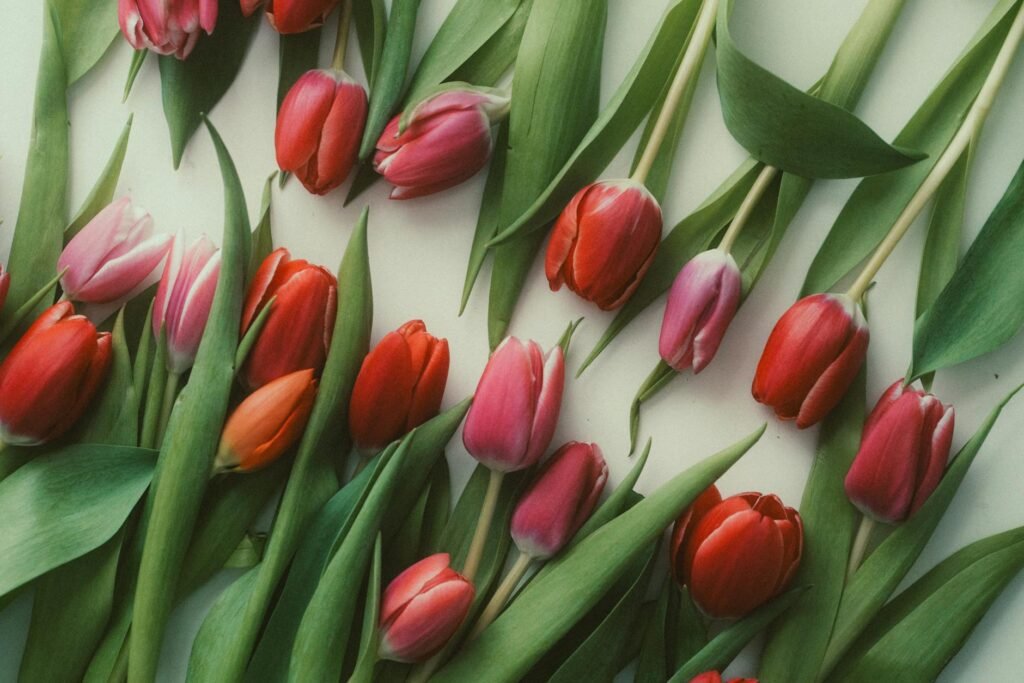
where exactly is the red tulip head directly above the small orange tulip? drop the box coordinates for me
[241,247,338,390]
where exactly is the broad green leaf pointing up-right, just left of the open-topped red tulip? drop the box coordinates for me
[433,426,764,683]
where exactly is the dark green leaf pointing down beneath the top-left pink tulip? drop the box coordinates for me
[159,0,262,169]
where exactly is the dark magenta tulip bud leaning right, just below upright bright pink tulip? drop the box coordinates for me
[511,441,608,559]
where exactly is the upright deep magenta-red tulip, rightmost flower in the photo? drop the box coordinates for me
[846,380,954,523]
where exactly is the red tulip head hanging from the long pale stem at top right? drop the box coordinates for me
[753,294,868,429]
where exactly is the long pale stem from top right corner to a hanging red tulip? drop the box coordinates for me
[847,5,1024,301]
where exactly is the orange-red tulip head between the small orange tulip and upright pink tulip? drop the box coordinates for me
[348,321,449,451]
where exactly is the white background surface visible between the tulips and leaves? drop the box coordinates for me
[0,0,1024,681]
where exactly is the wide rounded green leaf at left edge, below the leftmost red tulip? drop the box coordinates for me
[0,443,154,595]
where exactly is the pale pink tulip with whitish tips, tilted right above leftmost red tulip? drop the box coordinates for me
[57,197,171,303]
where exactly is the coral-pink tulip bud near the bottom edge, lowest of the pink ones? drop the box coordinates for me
[379,553,473,663]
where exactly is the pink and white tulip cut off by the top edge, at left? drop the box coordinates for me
[118,0,217,59]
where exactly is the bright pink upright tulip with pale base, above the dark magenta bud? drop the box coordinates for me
[462,337,565,472]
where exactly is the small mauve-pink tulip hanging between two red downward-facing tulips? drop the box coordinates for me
[658,249,742,375]
